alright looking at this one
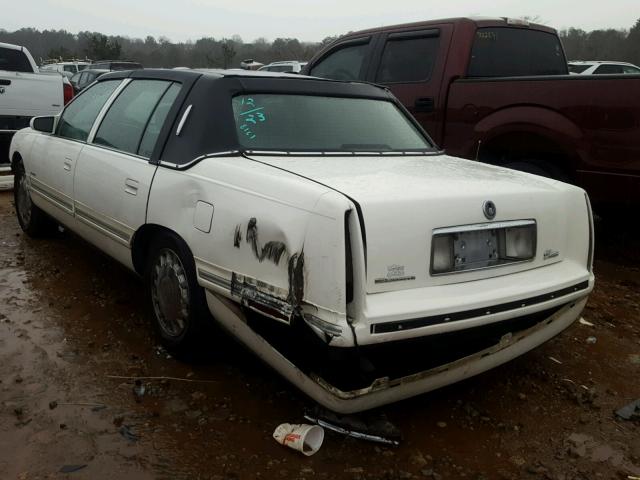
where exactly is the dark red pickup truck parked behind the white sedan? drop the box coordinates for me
[303,18,640,205]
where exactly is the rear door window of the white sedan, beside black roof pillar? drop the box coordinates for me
[93,80,171,154]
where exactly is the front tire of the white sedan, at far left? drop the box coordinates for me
[13,160,55,238]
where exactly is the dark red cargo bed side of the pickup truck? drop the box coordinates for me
[441,75,640,204]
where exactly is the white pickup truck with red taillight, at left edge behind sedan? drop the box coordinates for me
[0,43,73,189]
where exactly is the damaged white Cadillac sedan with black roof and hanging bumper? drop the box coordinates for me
[10,70,594,413]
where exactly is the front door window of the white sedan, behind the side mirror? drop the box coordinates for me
[58,80,120,142]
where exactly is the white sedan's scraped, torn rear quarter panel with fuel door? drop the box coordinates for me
[147,157,350,338]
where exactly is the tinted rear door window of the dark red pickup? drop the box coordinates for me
[376,30,439,83]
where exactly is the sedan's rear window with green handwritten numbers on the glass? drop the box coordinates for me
[232,94,432,152]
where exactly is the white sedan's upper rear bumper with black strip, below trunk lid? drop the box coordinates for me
[352,260,595,346]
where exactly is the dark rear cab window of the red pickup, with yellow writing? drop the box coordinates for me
[467,27,568,77]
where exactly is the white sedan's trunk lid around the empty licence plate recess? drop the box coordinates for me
[245,155,569,293]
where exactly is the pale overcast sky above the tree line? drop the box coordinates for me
[5,0,640,42]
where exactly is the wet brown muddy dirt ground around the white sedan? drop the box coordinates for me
[0,188,640,480]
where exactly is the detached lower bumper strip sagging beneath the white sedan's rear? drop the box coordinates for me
[207,292,587,414]
